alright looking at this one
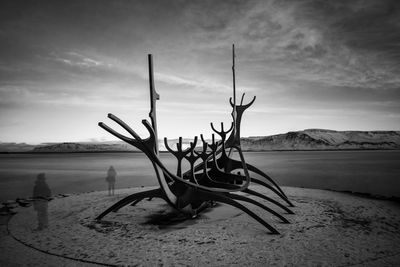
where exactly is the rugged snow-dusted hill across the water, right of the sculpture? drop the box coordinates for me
[241,129,400,151]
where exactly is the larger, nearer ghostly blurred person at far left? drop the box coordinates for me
[33,173,51,230]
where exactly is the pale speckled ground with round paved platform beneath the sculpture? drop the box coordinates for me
[0,187,400,266]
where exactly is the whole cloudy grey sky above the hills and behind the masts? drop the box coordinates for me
[0,0,400,144]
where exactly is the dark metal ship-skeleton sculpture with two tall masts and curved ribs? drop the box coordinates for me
[96,45,293,234]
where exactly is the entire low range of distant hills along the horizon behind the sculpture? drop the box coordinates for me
[0,129,400,153]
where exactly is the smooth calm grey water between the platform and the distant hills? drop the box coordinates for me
[0,151,400,201]
